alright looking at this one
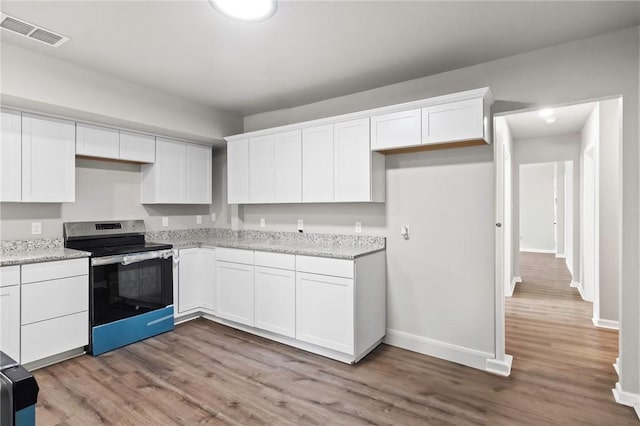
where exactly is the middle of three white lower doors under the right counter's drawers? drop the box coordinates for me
[255,266,296,338]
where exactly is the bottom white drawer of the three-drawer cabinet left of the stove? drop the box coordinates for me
[21,311,89,364]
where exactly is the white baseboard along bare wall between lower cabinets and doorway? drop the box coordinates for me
[384,329,495,371]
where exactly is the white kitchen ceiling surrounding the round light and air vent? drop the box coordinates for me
[1,0,640,115]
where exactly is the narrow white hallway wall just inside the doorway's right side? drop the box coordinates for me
[594,99,622,325]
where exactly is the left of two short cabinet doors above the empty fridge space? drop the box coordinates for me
[371,109,421,150]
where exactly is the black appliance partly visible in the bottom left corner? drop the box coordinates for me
[0,351,40,426]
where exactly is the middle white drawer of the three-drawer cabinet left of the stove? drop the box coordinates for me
[22,275,89,325]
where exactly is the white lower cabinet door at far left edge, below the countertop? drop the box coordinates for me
[0,285,20,362]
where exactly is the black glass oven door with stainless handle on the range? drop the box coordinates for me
[90,250,173,327]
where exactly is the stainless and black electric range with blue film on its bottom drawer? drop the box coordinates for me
[63,220,173,355]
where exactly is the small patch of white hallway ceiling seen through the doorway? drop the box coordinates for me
[505,102,595,140]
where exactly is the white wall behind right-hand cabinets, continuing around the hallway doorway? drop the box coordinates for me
[244,27,640,392]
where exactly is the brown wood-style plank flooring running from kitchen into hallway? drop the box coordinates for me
[35,254,637,425]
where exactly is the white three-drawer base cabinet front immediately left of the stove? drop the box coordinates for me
[20,259,89,364]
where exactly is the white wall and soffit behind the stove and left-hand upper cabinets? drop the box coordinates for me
[0,43,242,240]
